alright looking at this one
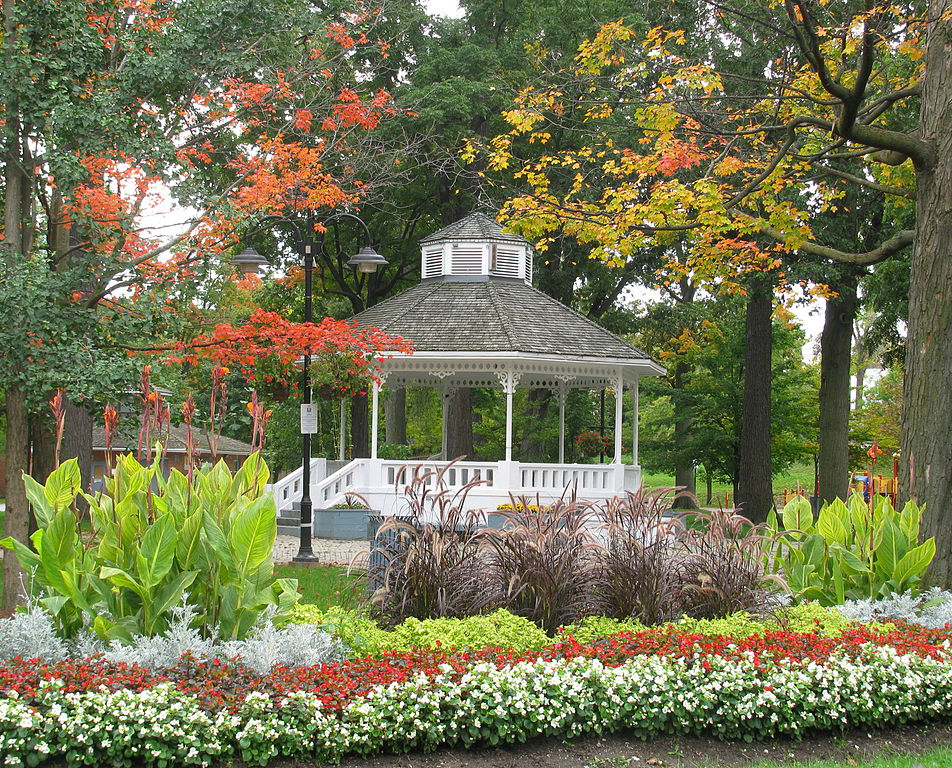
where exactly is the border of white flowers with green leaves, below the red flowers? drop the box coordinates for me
[0,643,952,768]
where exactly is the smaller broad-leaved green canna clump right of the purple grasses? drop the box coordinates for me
[766,494,935,605]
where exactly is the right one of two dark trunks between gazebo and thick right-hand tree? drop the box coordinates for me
[819,275,857,501]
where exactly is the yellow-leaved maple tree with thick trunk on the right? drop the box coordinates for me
[470,0,952,583]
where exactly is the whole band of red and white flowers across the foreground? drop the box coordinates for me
[0,625,952,766]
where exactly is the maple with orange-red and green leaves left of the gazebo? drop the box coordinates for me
[0,0,412,603]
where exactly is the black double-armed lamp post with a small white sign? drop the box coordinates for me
[232,212,389,564]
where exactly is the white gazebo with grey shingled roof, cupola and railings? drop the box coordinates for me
[274,213,664,514]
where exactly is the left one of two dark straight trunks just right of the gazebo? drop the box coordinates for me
[735,279,773,522]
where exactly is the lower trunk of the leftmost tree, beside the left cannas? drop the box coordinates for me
[3,387,30,611]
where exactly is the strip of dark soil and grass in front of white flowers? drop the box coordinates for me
[271,722,952,768]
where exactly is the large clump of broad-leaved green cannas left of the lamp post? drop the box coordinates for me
[0,450,298,642]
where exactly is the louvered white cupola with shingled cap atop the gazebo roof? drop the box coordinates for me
[420,212,532,285]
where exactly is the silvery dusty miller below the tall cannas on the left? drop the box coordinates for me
[0,600,349,674]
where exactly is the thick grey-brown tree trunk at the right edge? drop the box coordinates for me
[900,0,952,587]
